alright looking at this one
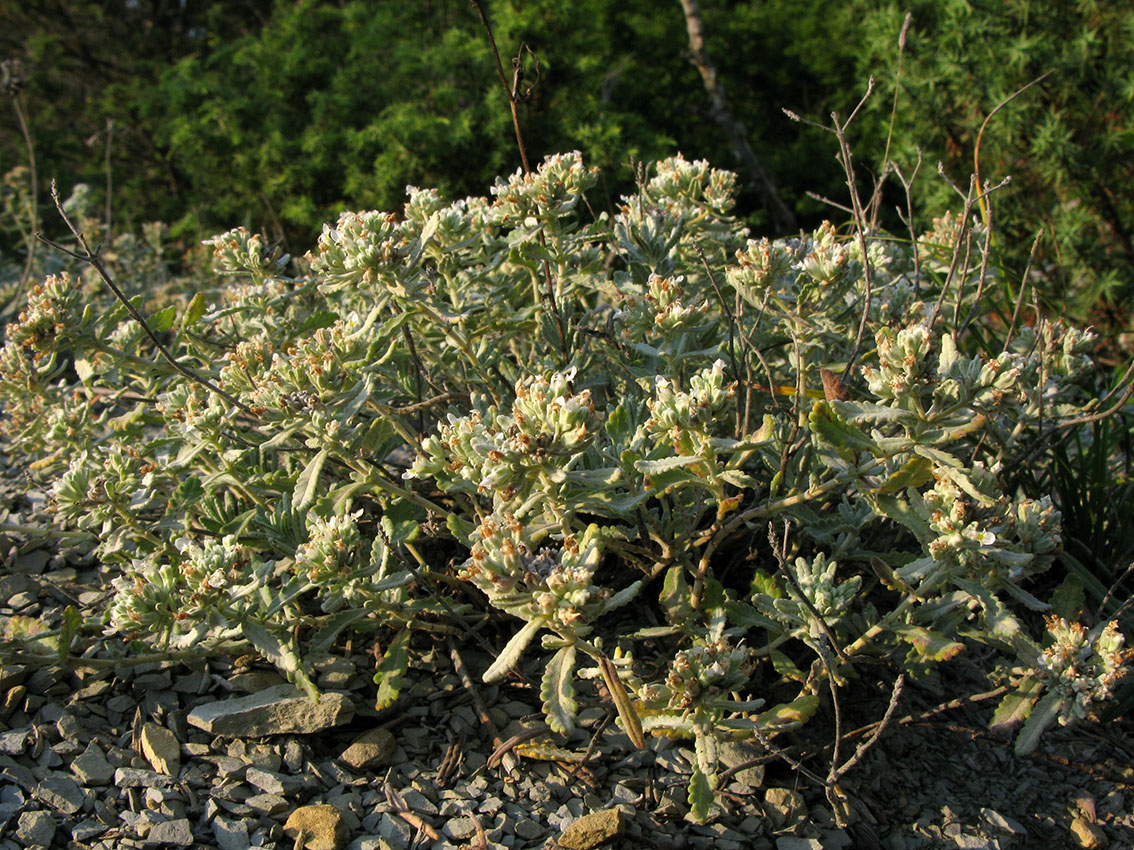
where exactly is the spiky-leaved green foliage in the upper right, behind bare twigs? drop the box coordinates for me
[861,0,1134,325]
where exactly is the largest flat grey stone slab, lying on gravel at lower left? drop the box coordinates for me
[187,685,354,738]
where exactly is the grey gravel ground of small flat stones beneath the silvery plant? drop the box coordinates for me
[0,466,1134,850]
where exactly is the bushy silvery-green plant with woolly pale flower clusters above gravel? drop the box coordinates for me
[0,154,1128,818]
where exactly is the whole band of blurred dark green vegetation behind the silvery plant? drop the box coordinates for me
[0,0,1134,331]
